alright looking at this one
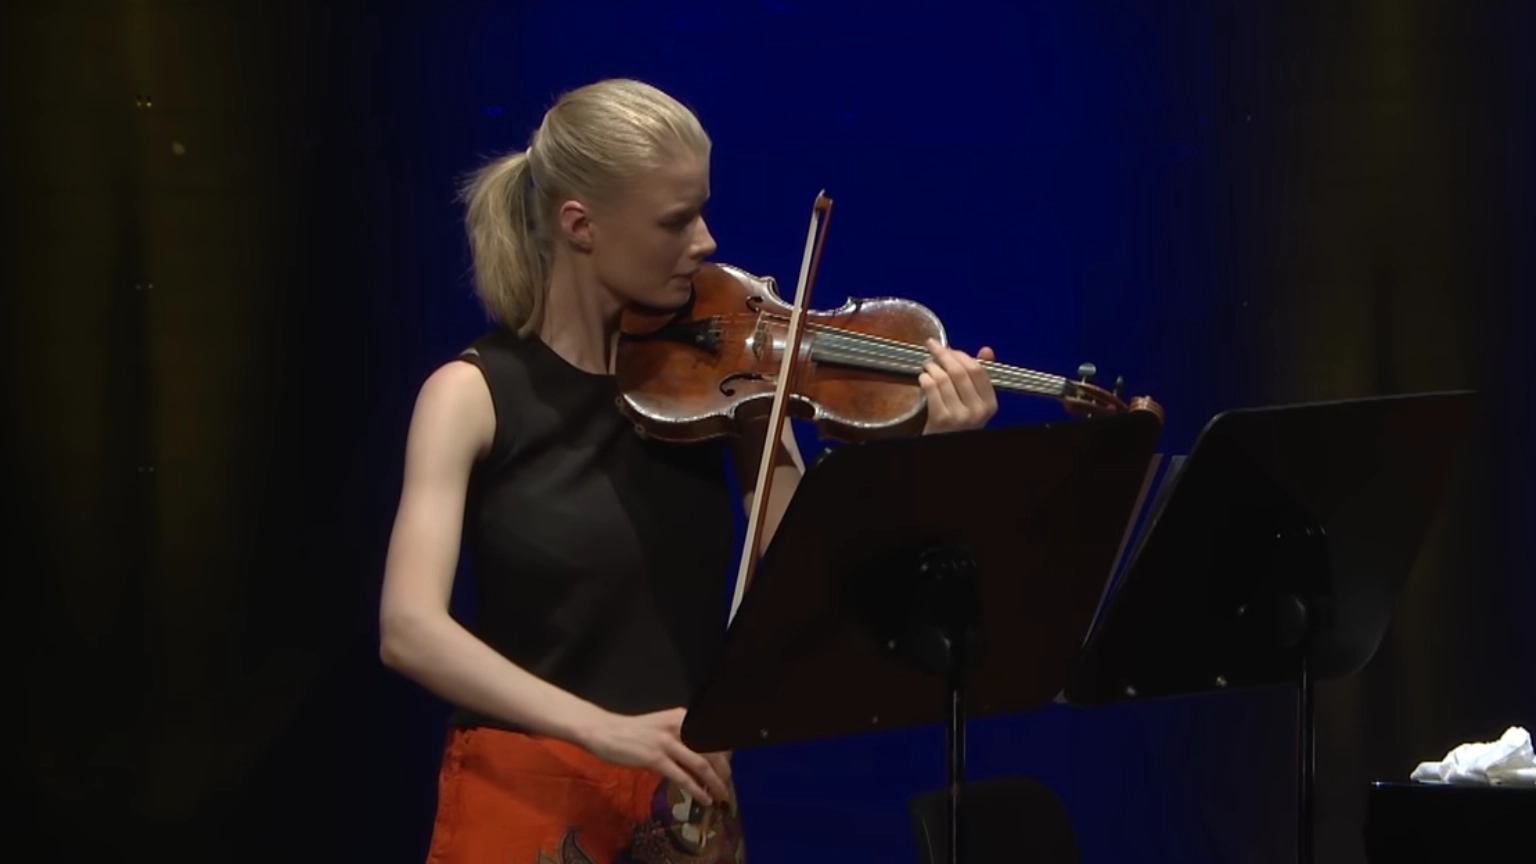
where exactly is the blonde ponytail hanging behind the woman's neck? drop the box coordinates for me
[462,151,550,335]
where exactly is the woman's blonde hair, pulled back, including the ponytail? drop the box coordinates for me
[461,78,710,335]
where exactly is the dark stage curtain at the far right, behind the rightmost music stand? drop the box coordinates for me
[1229,0,1536,861]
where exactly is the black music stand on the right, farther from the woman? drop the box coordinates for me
[1066,392,1478,862]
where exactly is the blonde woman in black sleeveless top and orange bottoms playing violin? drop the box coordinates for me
[379,80,997,864]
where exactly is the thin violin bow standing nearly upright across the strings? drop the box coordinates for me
[727,189,833,624]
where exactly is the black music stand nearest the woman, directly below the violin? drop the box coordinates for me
[682,414,1161,861]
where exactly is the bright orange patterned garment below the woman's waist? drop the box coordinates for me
[427,727,746,864]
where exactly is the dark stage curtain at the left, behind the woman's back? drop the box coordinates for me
[0,0,409,862]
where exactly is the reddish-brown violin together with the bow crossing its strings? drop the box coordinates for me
[614,192,1164,620]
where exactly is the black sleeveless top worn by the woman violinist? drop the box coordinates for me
[450,329,739,727]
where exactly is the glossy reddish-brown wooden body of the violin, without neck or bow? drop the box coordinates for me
[616,263,945,441]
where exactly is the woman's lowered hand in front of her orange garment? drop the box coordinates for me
[578,709,731,806]
